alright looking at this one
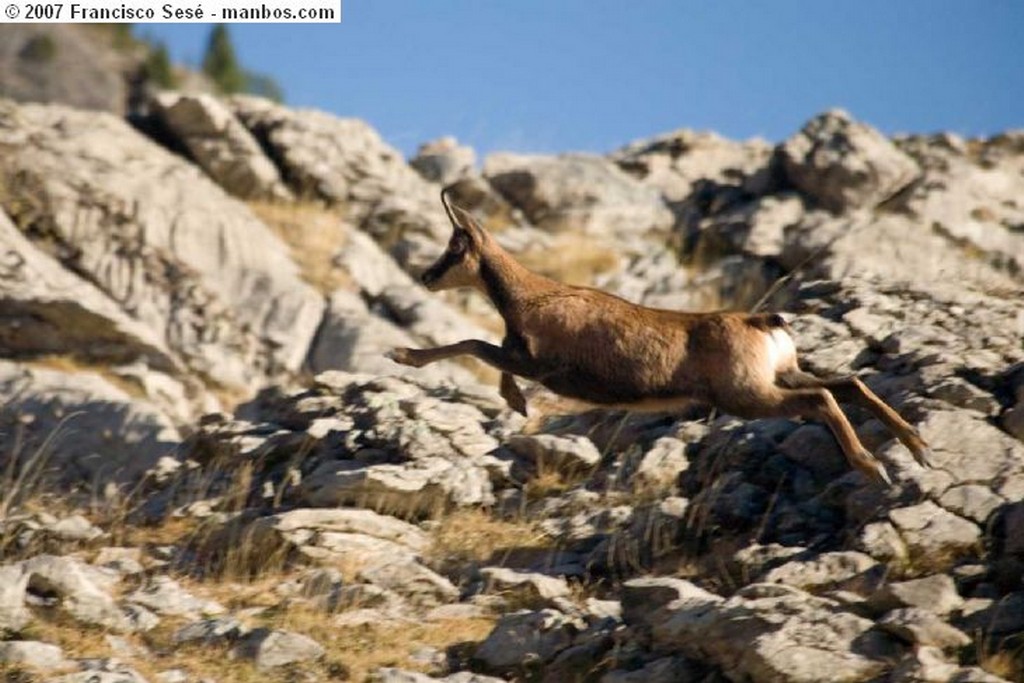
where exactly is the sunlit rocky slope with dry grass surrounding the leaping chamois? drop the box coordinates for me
[0,93,1024,683]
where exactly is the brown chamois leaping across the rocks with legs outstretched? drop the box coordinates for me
[388,187,928,483]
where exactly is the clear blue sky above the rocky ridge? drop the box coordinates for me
[136,0,1024,155]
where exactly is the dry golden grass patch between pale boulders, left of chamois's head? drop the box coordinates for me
[249,197,352,294]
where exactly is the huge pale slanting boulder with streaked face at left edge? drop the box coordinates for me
[0,101,324,387]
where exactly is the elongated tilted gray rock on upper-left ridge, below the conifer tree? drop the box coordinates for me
[153,92,291,200]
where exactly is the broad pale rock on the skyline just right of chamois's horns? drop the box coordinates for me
[483,154,674,237]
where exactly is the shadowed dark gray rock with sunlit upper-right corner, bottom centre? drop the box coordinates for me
[473,609,584,672]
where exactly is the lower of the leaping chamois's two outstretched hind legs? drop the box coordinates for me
[746,387,892,485]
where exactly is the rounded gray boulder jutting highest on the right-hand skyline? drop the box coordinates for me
[779,110,920,212]
